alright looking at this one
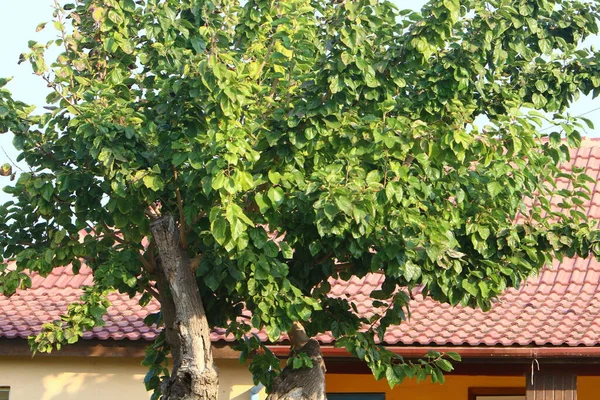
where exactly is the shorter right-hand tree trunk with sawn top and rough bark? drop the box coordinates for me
[267,323,326,400]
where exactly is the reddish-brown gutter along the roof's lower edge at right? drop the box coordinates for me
[268,345,600,359]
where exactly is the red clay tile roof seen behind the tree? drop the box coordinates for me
[0,139,600,346]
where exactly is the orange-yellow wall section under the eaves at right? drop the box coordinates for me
[327,374,600,400]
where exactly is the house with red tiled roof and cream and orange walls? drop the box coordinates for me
[0,139,600,400]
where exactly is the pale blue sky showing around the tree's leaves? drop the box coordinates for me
[0,0,600,202]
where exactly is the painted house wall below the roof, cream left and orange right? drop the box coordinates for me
[0,357,600,400]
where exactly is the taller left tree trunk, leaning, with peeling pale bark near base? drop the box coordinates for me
[151,215,219,400]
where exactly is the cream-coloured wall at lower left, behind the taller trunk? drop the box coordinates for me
[0,357,264,400]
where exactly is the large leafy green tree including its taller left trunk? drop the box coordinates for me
[0,0,600,399]
